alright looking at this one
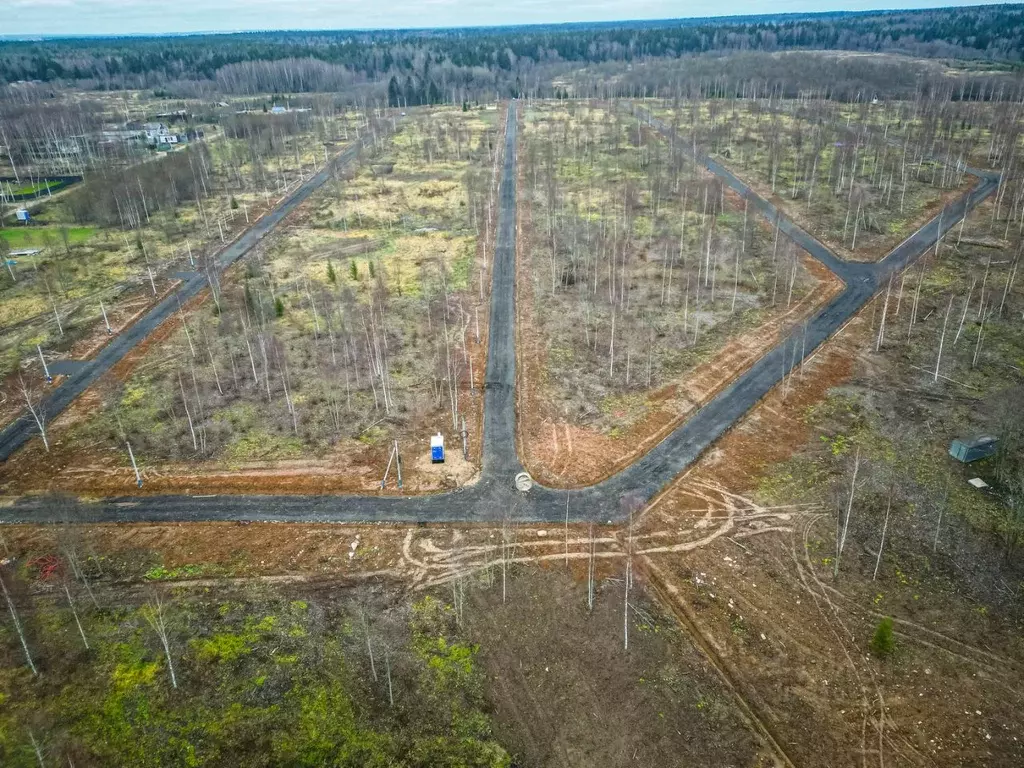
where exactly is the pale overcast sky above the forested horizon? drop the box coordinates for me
[0,0,1007,35]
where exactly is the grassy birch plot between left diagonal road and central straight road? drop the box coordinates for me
[4,110,500,493]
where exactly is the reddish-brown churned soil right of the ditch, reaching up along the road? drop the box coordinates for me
[622,288,1024,767]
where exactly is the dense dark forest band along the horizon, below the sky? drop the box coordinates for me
[0,4,1024,105]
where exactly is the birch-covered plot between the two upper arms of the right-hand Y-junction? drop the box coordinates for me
[654,98,973,261]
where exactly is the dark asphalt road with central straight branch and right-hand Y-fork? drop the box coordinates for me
[0,103,997,522]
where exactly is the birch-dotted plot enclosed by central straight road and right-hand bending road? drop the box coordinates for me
[519,103,838,483]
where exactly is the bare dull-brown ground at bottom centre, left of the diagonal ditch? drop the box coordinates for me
[466,569,764,768]
